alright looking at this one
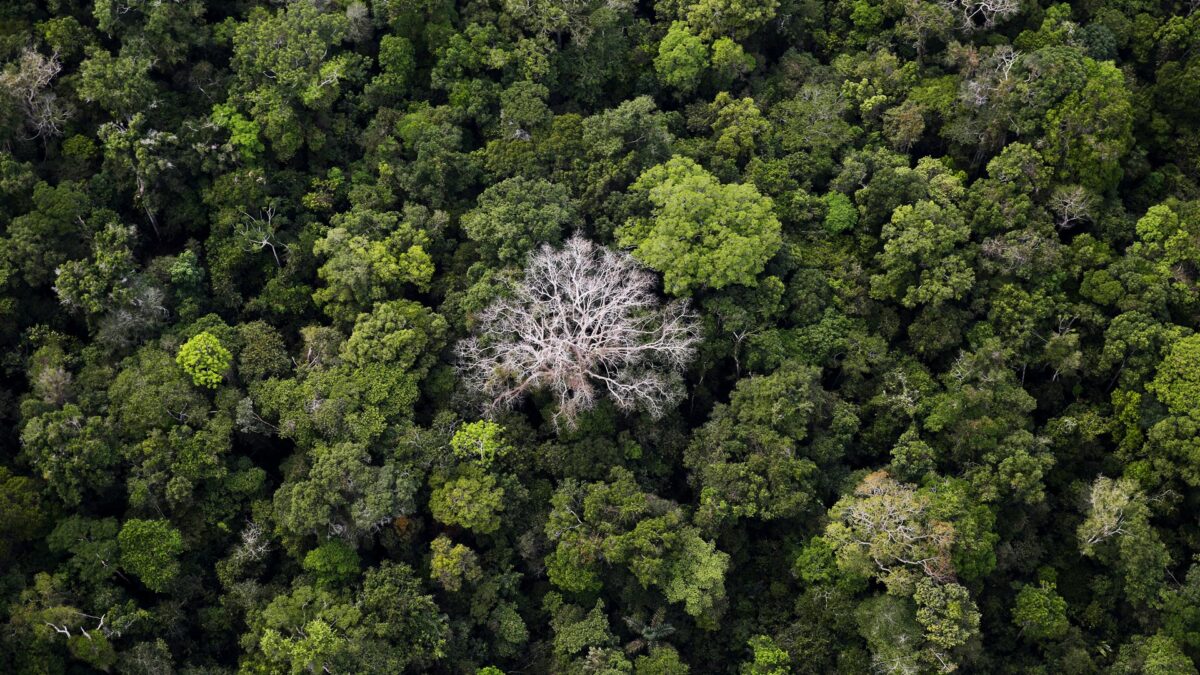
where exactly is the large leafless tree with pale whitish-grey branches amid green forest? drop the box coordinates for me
[457,235,700,426]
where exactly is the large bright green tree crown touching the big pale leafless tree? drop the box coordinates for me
[617,156,781,295]
